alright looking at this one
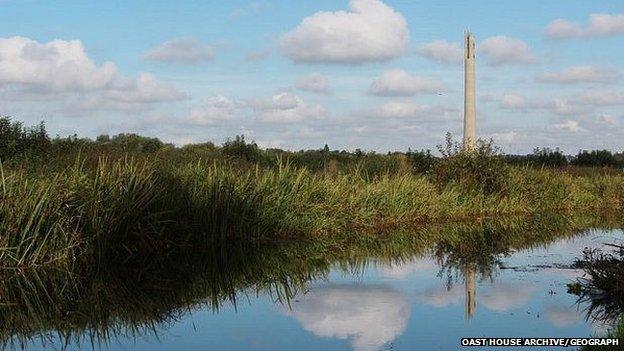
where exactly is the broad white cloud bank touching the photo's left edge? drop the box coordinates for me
[0,37,186,109]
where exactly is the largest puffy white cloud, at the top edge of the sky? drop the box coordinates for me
[280,0,409,64]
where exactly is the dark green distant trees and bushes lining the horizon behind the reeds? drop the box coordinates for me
[0,117,624,173]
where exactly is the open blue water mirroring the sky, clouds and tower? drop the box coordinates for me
[12,230,624,351]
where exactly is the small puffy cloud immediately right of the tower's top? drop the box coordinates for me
[477,35,535,66]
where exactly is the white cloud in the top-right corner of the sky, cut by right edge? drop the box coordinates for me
[546,13,624,39]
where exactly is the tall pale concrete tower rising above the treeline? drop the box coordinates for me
[464,31,477,150]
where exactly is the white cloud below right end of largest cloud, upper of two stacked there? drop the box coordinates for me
[369,69,444,96]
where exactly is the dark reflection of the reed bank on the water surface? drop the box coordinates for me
[0,216,617,349]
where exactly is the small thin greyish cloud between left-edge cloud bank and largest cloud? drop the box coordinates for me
[143,38,214,65]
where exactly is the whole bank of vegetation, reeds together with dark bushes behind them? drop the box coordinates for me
[0,119,624,270]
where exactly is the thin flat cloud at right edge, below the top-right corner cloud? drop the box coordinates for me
[537,66,621,84]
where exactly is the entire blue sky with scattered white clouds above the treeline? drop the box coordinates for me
[0,0,624,153]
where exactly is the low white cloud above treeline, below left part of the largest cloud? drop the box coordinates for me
[249,92,327,123]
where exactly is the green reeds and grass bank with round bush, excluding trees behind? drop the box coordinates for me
[0,151,624,269]
